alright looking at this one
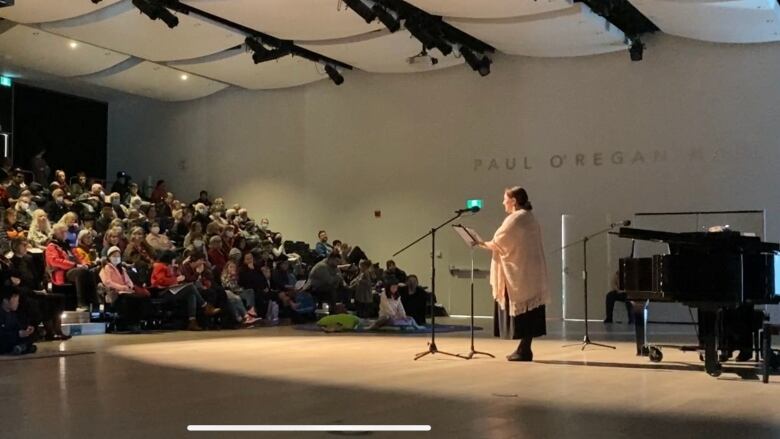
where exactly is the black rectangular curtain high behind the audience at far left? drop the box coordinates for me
[13,83,108,180]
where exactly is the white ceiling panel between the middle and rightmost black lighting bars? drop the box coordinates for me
[447,3,627,57]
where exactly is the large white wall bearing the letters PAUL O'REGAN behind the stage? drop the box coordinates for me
[109,32,780,317]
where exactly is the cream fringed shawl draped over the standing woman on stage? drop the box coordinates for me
[485,209,550,316]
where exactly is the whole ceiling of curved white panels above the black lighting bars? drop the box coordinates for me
[0,0,780,101]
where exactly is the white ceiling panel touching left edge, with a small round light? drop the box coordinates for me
[0,24,128,77]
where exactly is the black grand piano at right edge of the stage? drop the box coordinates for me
[617,227,780,376]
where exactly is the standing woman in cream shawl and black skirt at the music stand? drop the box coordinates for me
[479,186,550,361]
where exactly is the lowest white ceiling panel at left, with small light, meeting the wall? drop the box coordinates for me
[85,61,227,101]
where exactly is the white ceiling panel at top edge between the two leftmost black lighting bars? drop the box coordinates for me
[184,0,384,41]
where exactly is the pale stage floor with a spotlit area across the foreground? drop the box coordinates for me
[0,319,780,439]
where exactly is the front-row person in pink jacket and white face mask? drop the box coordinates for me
[100,246,152,332]
